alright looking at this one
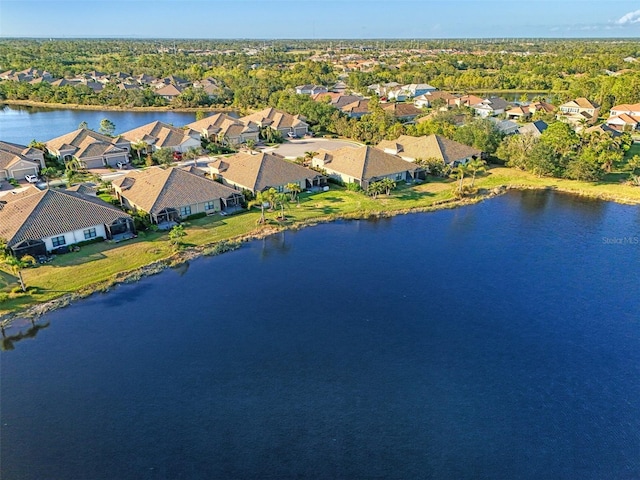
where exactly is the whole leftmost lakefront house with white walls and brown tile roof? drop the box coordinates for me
[0,186,135,255]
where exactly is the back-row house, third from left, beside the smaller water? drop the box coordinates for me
[121,121,201,152]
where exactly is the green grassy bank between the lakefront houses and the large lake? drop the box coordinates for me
[0,167,640,318]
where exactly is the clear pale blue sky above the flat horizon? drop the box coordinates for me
[0,0,640,38]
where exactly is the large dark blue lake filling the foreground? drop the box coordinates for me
[0,192,640,480]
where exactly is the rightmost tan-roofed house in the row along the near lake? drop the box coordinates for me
[377,134,482,166]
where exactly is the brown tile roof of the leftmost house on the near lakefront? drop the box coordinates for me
[0,187,129,246]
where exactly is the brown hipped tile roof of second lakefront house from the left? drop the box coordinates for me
[112,167,238,214]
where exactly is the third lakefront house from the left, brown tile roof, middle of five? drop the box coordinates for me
[209,152,325,194]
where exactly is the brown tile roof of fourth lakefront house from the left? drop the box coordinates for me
[314,146,417,181]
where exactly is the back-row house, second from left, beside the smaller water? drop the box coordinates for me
[45,128,129,169]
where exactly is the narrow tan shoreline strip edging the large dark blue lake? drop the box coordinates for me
[0,184,640,331]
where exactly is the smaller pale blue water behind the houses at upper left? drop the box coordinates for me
[0,106,210,145]
